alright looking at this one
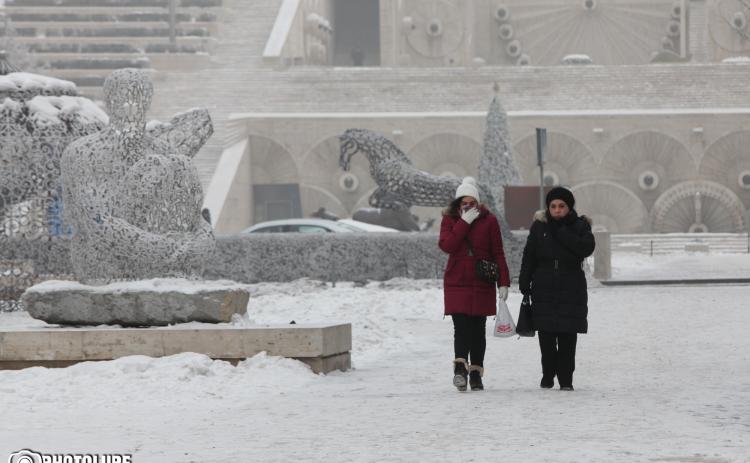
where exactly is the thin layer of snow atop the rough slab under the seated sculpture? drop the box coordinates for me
[26,278,247,294]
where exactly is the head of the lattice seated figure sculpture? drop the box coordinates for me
[104,68,154,125]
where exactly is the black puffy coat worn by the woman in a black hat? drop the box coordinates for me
[519,210,595,333]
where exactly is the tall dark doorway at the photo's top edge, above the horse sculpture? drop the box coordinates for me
[333,0,380,66]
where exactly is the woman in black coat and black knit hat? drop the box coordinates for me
[519,187,595,391]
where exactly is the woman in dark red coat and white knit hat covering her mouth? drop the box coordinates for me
[438,177,510,391]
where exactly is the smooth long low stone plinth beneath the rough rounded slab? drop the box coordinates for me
[0,324,352,373]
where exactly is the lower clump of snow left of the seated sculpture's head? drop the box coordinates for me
[28,96,109,125]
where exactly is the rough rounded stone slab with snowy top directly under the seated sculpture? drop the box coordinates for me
[21,279,250,326]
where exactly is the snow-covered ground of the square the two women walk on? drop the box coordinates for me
[0,280,750,462]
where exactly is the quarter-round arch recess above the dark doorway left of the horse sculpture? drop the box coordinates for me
[248,135,299,185]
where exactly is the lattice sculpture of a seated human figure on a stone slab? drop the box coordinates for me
[61,69,215,283]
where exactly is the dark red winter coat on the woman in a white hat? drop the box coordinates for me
[438,206,510,316]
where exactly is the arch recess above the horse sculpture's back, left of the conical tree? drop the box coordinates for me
[407,132,482,178]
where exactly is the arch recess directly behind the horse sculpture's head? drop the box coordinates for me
[300,135,376,213]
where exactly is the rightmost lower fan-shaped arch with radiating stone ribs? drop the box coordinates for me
[650,180,746,233]
